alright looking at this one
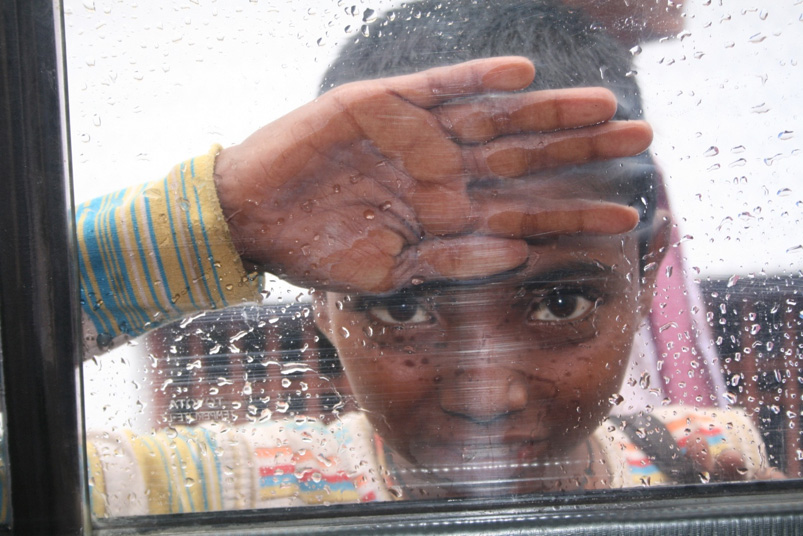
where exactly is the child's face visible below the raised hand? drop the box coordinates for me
[322,230,651,491]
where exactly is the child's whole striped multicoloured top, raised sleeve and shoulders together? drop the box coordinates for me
[77,147,766,517]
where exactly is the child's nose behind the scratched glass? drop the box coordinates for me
[439,323,529,423]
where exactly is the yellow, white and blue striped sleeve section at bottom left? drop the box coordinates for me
[87,424,253,518]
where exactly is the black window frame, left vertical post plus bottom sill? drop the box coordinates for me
[0,0,803,535]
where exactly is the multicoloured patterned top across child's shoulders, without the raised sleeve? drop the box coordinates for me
[87,406,765,517]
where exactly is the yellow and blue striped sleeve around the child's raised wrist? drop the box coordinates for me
[76,146,259,350]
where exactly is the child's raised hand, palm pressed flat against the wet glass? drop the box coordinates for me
[215,57,652,292]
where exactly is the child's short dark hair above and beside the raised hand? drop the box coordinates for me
[321,0,658,237]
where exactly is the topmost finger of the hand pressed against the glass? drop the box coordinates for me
[383,56,535,108]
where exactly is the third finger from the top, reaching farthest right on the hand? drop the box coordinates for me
[463,121,652,178]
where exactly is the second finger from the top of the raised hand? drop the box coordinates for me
[433,88,616,143]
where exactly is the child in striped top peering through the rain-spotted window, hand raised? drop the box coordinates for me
[79,1,764,515]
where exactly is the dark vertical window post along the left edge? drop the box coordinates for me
[0,0,86,534]
